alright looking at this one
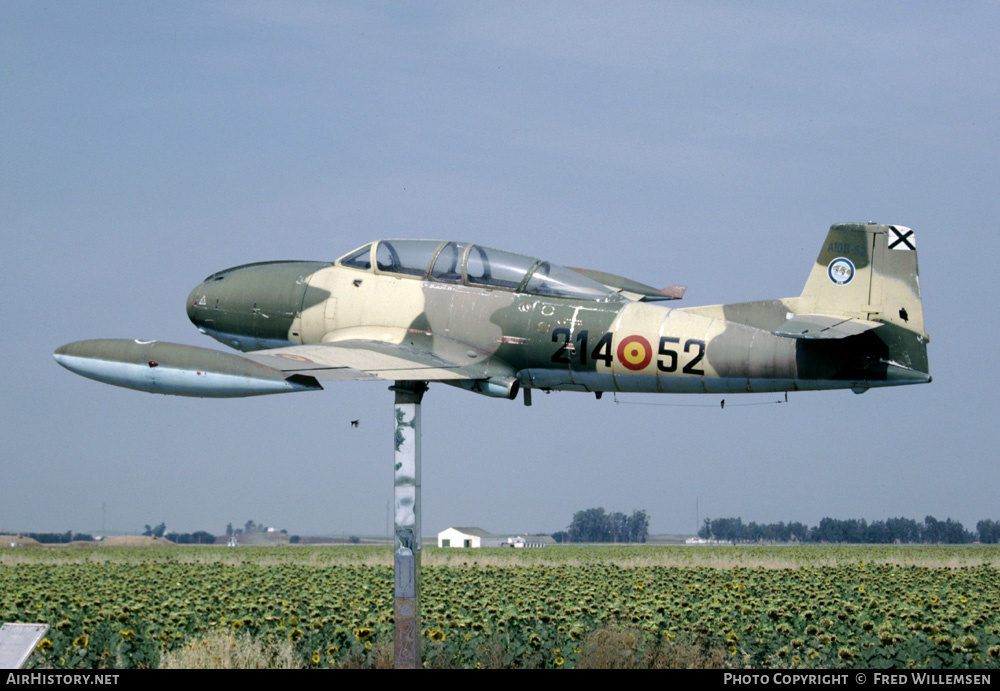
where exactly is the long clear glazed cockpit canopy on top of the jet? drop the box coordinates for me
[337,240,618,300]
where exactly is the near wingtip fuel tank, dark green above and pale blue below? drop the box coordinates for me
[53,339,323,398]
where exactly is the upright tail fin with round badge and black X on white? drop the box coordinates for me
[799,223,924,336]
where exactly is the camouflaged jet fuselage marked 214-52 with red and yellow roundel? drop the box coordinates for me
[187,235,928,393]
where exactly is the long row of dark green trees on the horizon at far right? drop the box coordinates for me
[698,516,1000,545]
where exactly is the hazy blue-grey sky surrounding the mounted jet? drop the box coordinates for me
[0,2,1000,534]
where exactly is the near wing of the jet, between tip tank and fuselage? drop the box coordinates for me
[242,334,514,381]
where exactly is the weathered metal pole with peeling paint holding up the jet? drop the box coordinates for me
[389,381,427,669]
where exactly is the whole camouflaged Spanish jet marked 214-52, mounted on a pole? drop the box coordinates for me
[55,223,931,404]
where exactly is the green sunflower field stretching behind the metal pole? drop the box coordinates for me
[0,546,1000,668]
